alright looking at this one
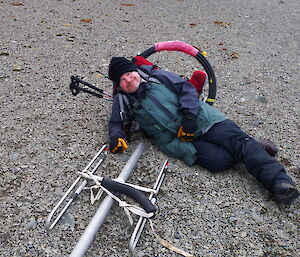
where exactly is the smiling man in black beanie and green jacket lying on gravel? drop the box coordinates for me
[109,57,299,204]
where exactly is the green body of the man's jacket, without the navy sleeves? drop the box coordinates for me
[132,84,226,165]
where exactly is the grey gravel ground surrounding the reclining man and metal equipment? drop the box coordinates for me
[0,0,300,257]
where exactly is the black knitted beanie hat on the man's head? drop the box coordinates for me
[108,57,137,84]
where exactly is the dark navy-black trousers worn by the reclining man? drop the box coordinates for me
[193,119,292,192]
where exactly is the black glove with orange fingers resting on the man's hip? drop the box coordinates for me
[177,113,197,142]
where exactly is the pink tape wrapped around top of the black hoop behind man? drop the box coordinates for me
[154,41,199,57]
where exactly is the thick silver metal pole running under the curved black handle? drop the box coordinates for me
[70,143,145,257]
